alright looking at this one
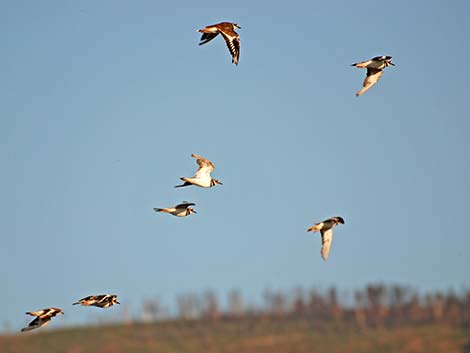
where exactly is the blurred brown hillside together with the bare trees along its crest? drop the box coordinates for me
[0,284,470,353]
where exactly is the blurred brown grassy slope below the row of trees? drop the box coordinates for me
[0,317,470,353]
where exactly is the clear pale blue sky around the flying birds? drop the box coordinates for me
[0,0,470,330]
